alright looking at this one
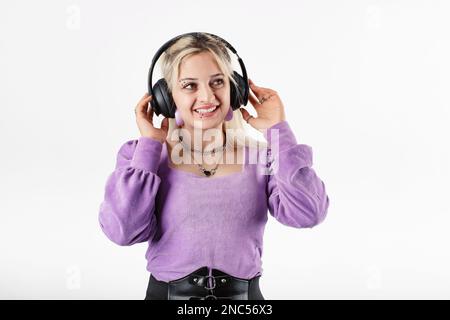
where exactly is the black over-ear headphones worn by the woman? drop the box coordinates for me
[148,32,249,118]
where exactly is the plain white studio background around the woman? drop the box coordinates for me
[0,0,450,299]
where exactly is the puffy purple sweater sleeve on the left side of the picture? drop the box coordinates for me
[99,137,162,246]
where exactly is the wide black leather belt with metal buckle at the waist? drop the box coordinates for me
[161,267,260,300]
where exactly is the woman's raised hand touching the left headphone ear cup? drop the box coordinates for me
[135,93,169,143]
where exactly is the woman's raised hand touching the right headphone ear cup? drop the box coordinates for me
[239,79,286,130]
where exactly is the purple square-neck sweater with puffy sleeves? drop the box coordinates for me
[99,121,329,281]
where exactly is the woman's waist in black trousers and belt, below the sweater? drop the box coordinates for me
[145,267,264,300]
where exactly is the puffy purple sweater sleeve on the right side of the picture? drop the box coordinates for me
[264,121,329,228]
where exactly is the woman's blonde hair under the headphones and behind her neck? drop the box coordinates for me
[159,33,267,148]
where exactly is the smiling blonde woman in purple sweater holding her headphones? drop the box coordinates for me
[99,33,329,300]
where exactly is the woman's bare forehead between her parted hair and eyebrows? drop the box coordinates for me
[179,52,221,78]
